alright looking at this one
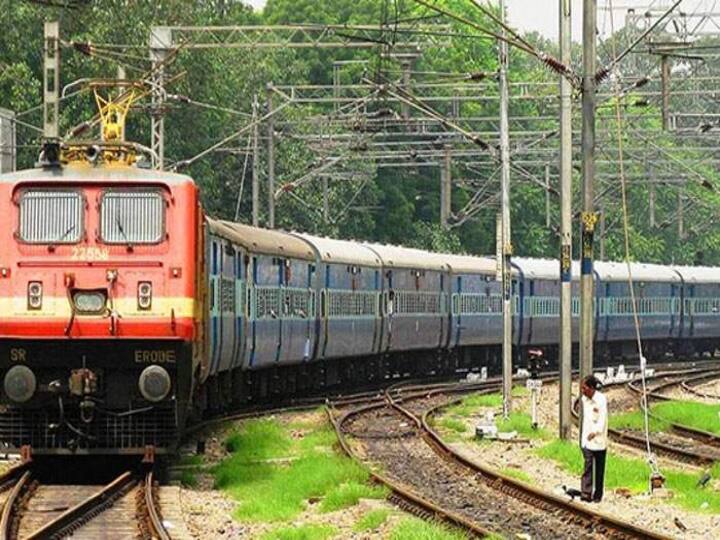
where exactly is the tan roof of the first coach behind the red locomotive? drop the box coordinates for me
[207,218,315,261]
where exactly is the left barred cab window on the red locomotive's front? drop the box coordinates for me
[18,189,84,244]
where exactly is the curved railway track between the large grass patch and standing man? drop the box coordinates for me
[327,376,666,538]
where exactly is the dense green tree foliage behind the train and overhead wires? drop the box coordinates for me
[0,0,720,264]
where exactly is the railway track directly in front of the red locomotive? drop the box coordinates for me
[0,463,170,540]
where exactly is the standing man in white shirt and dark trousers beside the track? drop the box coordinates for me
[580,375,608,502]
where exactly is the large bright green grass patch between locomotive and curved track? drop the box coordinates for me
[213,419,385,522]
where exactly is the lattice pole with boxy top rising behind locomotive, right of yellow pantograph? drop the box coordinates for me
[150,26,172,171]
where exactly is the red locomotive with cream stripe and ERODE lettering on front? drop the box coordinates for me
[0,145,202,453]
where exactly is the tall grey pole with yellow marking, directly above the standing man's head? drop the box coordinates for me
[580,0,597,380]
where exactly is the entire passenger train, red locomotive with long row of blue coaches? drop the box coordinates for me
[0,144,720,457]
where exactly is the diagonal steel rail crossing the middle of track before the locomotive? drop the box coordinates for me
[26,472,136,540]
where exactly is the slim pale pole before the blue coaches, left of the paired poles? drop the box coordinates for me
[498,0,512,418]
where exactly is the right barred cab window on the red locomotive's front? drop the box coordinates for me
[100,190,165,244]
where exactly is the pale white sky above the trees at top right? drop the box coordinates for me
[246,0,720,41]
